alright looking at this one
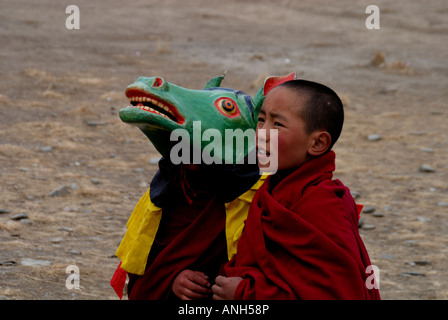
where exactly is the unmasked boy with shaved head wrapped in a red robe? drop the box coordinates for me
[212,80,380,300]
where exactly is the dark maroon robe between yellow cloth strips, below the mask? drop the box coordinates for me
[128,189,227,300]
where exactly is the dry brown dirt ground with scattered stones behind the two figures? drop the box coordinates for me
[0,0,448,300]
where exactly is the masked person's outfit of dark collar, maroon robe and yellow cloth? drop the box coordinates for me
[111,158,264,300]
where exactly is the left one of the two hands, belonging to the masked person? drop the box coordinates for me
[172,269,210,300]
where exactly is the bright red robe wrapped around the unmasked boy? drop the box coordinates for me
[225,151,380,300]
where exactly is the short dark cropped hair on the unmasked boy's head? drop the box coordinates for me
[280,80,344,150]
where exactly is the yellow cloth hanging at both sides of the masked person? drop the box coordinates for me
[115,175,267,275]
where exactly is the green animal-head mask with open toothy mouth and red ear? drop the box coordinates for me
[119,73,295,163]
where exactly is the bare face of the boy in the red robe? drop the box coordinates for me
[257,87,314,170]
